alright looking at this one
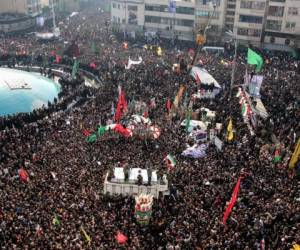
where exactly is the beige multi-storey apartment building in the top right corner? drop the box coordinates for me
[234,0,300,48]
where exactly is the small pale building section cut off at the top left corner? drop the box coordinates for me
[0,0,42,17]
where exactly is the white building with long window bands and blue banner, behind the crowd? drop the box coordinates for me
[111,0,195,40]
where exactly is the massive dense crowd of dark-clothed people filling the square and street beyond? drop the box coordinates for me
[0,4,300,250]
